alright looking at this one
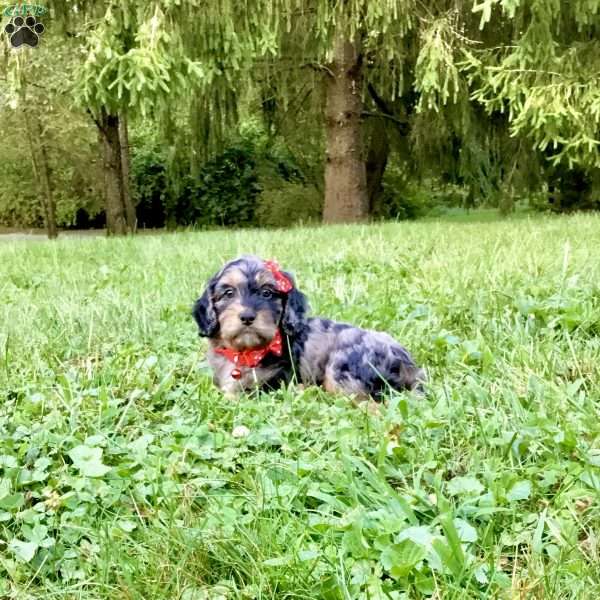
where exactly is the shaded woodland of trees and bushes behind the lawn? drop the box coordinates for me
[0,0,600,237]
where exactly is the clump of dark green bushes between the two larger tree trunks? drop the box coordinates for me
[131,127,321,227]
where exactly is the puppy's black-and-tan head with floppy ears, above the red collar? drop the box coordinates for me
[193,256,308,350]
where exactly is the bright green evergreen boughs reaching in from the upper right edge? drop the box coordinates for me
[461,0,600,211]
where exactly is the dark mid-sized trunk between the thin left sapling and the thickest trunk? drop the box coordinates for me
[96,109,127,235]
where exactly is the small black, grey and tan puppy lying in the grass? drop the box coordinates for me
[193,256,425,399]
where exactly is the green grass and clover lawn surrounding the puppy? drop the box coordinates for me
[0,216,600,600]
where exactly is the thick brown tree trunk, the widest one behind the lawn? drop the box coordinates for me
[323,25,369,223]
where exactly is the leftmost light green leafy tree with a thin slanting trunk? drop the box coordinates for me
[0,16,105,237]
